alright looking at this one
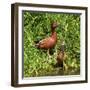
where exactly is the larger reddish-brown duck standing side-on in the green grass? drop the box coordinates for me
[35,21,58,50]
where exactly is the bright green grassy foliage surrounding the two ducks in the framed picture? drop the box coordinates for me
[23,11,80,77]
